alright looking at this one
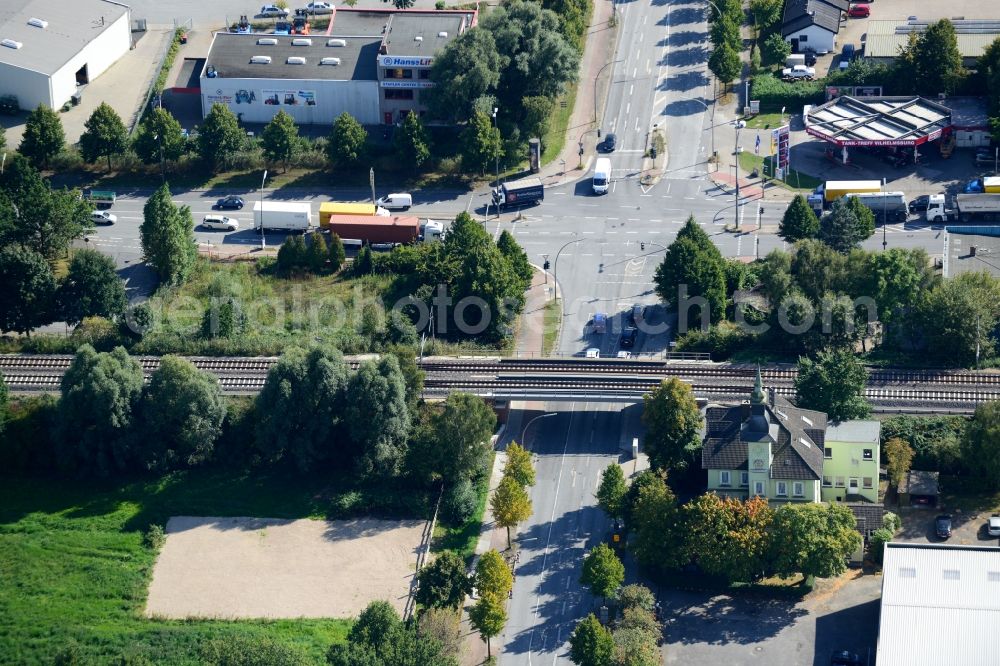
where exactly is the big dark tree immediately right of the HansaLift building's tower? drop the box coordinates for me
[422,27,501,122]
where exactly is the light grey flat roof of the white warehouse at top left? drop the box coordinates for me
[0,0,129,75]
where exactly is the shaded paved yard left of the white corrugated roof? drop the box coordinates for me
[661,570,882,666]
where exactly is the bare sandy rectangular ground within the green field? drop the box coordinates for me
[146,516,425,619]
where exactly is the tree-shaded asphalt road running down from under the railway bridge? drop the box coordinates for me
[496,403,640,666]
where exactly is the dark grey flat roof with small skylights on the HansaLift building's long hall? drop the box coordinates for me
[202,33,382,85]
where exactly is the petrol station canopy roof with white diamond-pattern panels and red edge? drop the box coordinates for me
[806,96,951,146]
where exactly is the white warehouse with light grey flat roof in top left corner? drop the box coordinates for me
[0,0,132,109]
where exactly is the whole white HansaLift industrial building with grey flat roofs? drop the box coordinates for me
[201,9,477,125]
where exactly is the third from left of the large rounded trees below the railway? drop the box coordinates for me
[256,348,352,471]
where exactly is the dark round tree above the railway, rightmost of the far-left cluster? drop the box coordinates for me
[58,249,128,324]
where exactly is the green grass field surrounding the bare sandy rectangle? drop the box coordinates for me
[0,470,464,664]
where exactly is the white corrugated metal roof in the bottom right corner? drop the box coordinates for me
[876,543,1000,666]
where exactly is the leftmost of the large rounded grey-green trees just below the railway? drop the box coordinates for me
[54,345,143,476]
